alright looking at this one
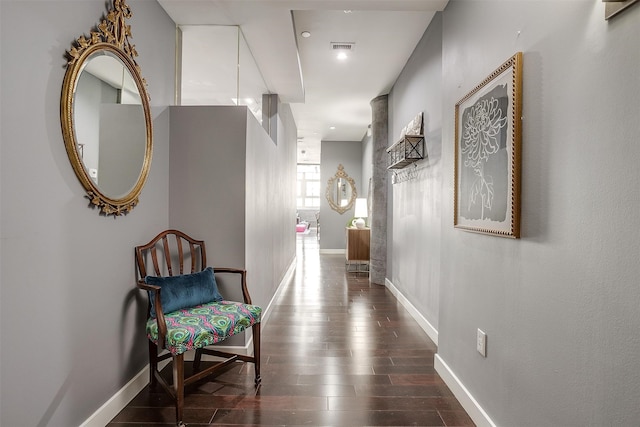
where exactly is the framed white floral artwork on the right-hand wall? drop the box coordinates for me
[454,52,522,238]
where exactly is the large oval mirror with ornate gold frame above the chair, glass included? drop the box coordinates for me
[60,0,152,216]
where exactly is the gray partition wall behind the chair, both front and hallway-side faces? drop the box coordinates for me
[169,105,297,324]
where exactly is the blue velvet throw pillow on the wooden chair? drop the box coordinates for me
[144,267,224,317]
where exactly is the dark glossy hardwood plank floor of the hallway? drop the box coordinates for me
[108,229,474,427]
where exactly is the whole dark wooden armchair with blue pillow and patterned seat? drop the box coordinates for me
[135,230,262,426]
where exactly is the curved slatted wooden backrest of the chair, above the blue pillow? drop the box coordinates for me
[135,230,207,279]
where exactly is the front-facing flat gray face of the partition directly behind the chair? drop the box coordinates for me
[169,106,247,268]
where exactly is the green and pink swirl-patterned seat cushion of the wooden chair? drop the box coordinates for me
[147,301,262,356]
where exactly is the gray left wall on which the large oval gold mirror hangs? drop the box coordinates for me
[0,0,175,427]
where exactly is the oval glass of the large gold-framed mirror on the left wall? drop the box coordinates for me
[73,50,146,199]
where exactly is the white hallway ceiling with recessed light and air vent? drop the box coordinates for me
[158,0,448,163]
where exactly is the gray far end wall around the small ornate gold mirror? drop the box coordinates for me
[320,141,369,251]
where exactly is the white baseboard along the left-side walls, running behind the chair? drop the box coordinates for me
[80,258,296,427]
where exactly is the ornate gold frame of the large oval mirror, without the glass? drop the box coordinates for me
[60,0,153,217]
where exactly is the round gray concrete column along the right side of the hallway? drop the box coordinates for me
[369,95,389,285]
